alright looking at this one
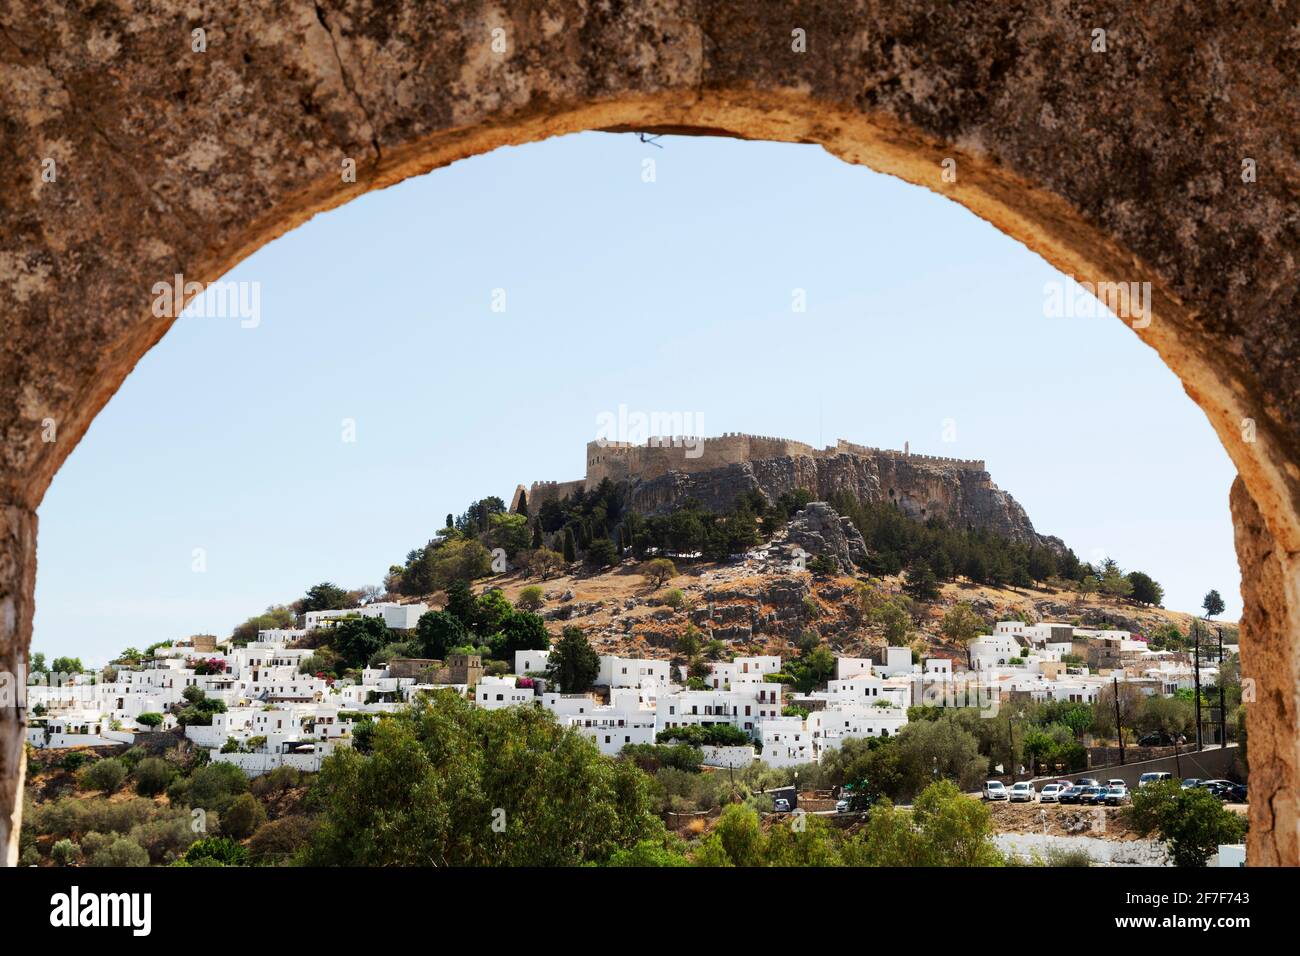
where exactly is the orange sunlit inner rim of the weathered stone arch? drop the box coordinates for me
[0,63,1300,862]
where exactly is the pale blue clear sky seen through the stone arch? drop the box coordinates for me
[34,133,1240,662]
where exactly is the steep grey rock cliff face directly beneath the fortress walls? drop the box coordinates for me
[631,453,1060,546]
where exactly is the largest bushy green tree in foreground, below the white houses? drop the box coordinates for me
[303,693,663,866]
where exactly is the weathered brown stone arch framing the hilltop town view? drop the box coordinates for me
[0,0,1300,865]
